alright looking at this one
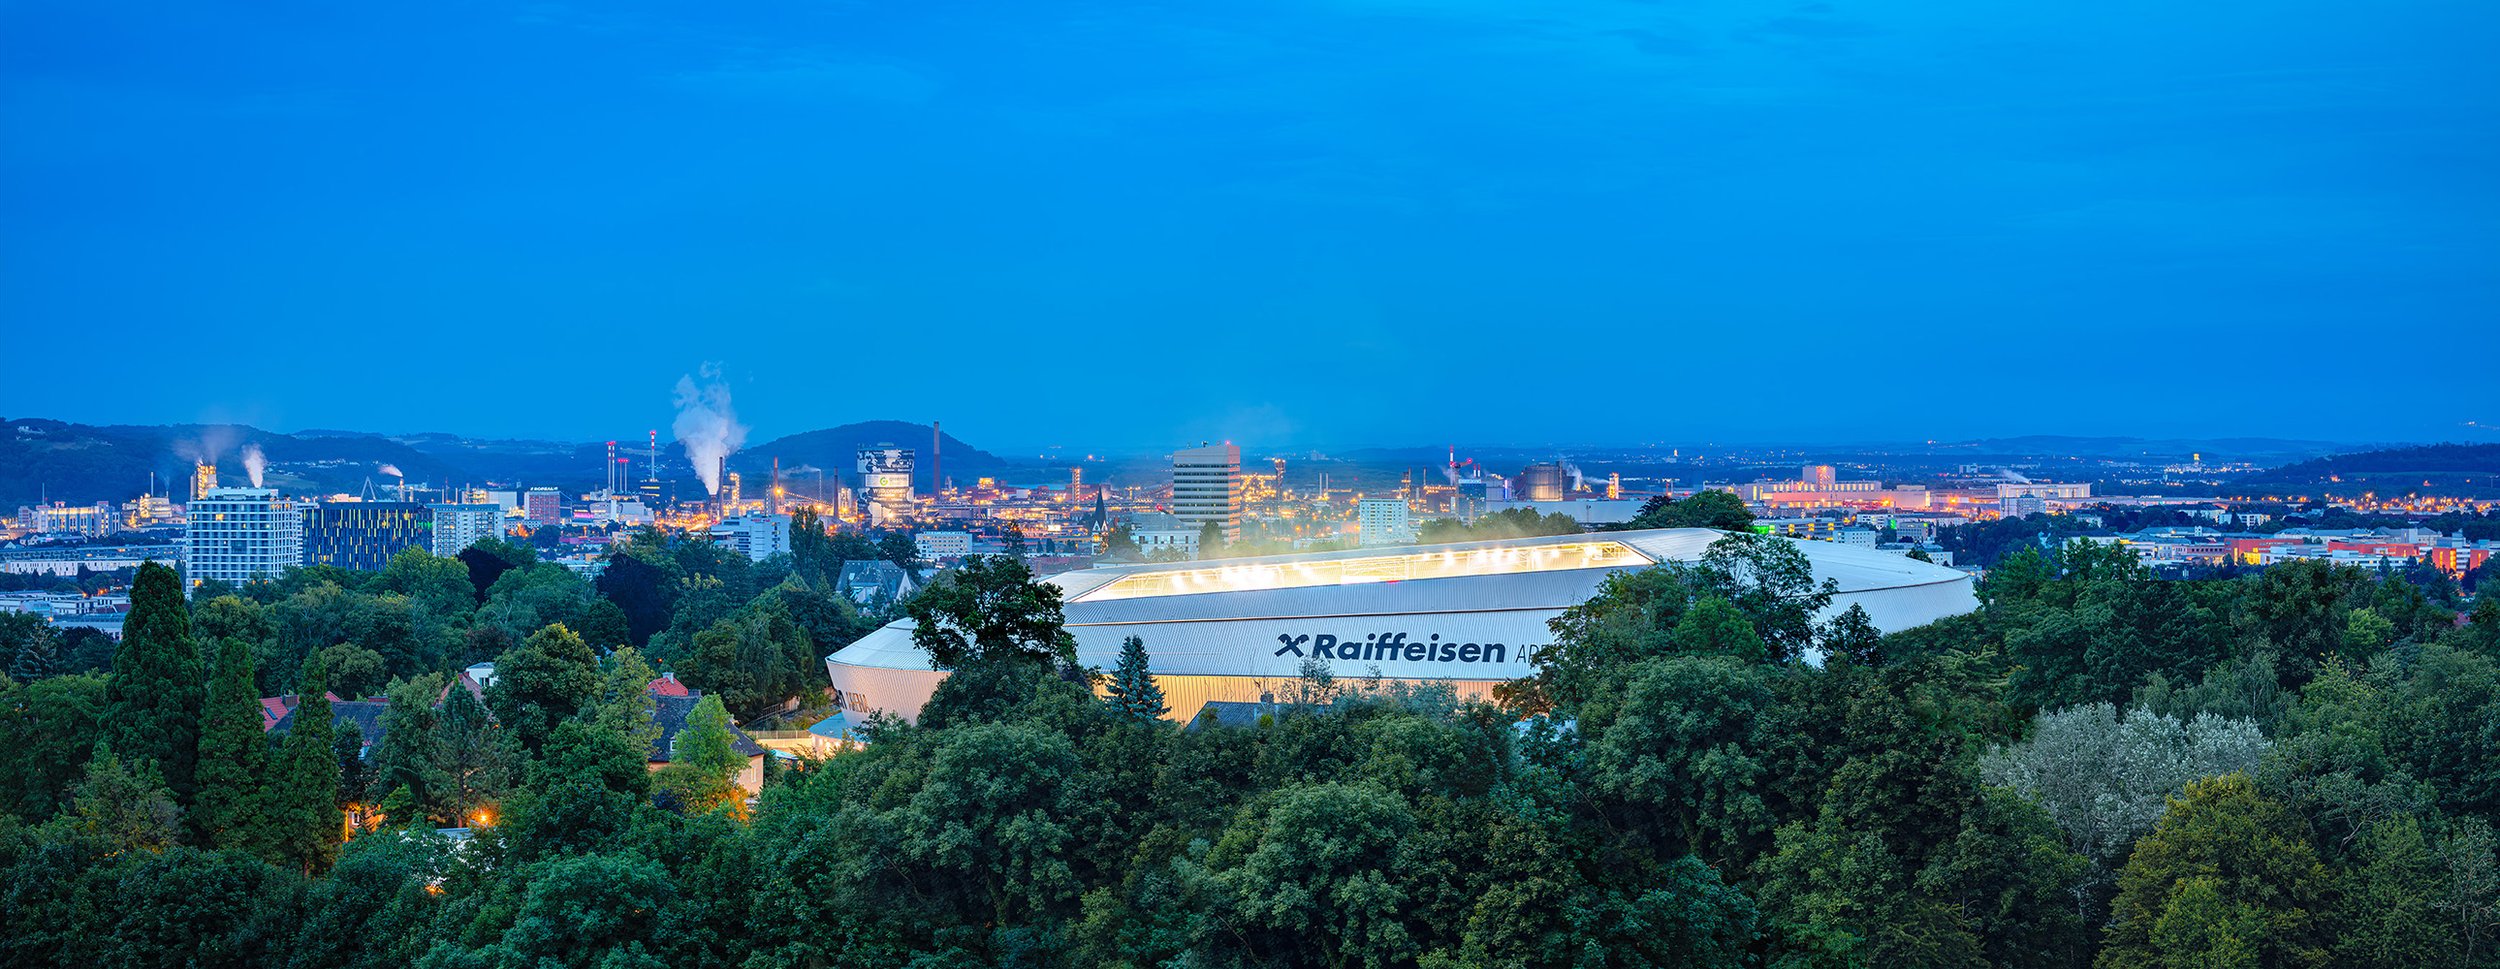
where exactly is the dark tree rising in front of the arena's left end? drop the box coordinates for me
[905,554,1078,669]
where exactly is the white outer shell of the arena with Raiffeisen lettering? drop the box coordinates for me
[825,529,1978,719]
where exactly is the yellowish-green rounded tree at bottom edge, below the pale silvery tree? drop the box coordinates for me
[2098,774,2330,969]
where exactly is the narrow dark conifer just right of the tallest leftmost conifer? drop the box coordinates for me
[190,637,273,857]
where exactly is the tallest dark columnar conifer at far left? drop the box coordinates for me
[105,562,205,804]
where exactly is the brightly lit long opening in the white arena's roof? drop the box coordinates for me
[1070,542,1653,602]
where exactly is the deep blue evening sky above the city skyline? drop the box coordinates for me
[0,0,2500,447]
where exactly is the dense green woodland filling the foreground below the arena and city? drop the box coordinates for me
[0,534,2500,969]
